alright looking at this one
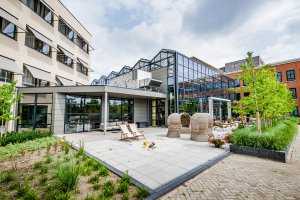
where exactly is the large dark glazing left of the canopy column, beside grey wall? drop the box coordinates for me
[65,95,101,133]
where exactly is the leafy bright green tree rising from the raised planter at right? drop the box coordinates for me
[232,52,295,132]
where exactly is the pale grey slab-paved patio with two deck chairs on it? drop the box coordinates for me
[59,128,227,190]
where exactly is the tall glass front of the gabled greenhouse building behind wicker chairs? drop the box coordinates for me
[175,52,231,114]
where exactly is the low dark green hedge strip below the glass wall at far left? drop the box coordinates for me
[0,130,52,146]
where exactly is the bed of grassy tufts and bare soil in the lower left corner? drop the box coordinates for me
[0,137,149,200]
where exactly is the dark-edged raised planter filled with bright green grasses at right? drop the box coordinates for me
[230,119,297,162]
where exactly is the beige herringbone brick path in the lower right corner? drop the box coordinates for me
[161,131,300,200]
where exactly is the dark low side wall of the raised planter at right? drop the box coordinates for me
[230,144,289,162]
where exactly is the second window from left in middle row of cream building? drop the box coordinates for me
[25,29,51,57]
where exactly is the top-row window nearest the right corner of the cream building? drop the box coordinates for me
[58,18,89,53]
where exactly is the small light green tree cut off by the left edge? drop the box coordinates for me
[0,81,20,135]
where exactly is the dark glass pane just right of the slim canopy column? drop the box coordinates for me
[109,98,133,123]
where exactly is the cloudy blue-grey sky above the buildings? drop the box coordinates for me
[61,0,300,79]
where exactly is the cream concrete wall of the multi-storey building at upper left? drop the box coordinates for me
[0,0,92,86]
